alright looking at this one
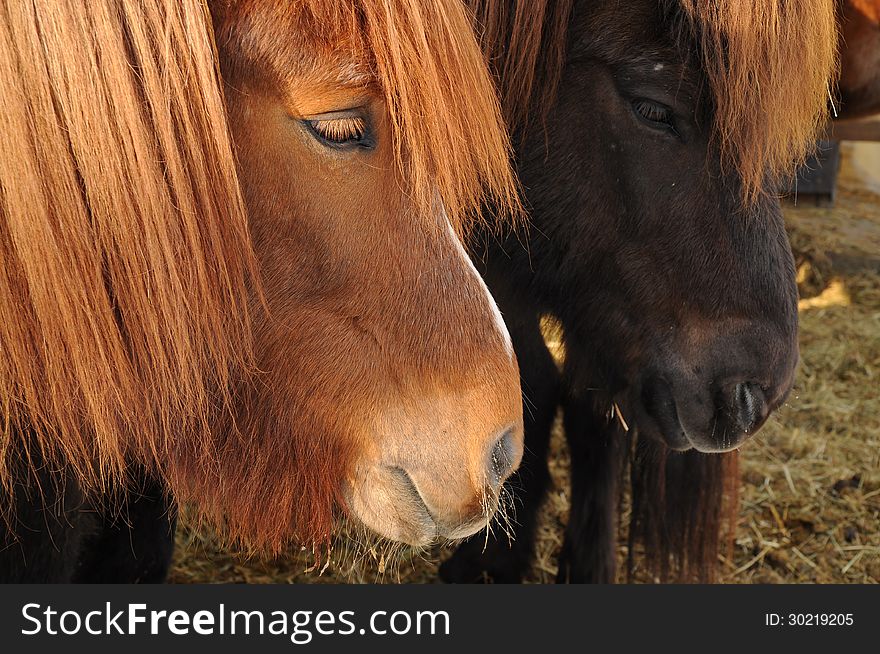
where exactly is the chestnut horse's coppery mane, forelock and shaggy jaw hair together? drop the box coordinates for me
[0,0,520,549]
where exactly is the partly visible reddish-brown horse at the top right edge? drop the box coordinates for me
[839,0,880,118]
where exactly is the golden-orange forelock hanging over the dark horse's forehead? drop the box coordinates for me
[670,0,837,201]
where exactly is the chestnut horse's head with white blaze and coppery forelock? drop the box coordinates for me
[204,0,522,544]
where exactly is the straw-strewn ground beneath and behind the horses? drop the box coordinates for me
[170,143,880,583]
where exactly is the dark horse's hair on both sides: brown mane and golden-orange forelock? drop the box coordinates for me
[471,0,837,202]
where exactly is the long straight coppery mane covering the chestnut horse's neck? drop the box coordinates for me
[0,0,254,498]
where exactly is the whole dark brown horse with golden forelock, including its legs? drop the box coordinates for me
[441,0,835,582]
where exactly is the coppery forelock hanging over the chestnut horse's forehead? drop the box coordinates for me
[359,0,521,231]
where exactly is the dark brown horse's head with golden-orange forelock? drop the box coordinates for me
[478,0,833,452]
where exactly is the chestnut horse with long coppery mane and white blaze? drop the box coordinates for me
[0,0,522,581]
